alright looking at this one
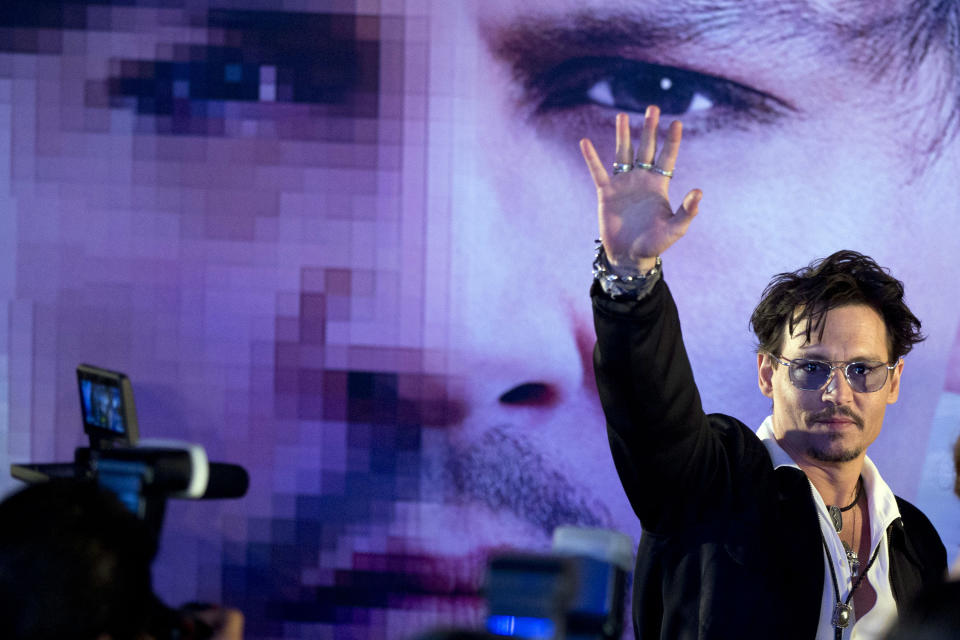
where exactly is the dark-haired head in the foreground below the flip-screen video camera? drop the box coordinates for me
[0,480,158,640]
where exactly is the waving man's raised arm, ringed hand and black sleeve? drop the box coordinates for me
[581,107,769,533]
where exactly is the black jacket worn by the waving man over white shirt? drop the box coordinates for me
[591,281,947,640]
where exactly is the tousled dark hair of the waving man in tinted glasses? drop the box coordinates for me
[750,251,925,362]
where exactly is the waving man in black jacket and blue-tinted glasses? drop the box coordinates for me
[581,107,946,640]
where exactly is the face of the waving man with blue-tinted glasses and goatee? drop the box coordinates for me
[757,304,903,466]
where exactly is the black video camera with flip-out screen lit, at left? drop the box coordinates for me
[10,364,250,640]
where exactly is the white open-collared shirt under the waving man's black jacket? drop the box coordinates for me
[757,416,900,640]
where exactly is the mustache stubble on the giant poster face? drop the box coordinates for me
[439,427,612,536]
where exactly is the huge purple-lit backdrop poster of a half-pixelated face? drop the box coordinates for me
[0,0,960,638]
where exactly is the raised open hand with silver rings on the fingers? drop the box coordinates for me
[580,106,703,272]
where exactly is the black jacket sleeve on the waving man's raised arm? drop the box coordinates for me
[591,280,770,533]
